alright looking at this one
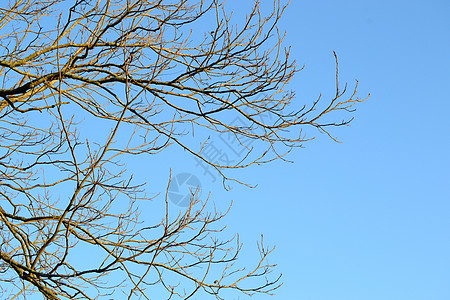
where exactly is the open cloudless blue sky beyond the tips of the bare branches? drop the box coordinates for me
[149,0,450,300]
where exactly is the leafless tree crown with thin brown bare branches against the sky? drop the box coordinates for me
[0,0,365,299]
